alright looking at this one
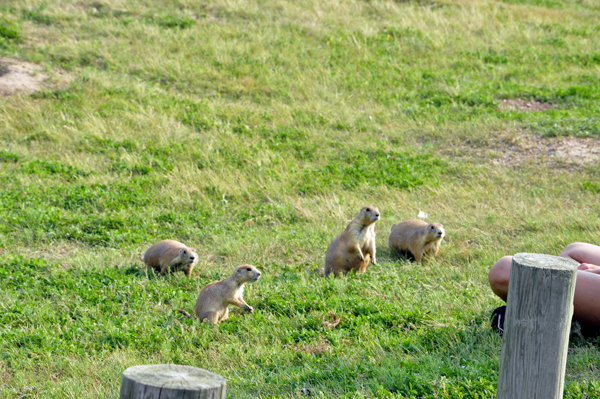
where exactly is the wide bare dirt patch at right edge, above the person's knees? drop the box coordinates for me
[493,132,600,166]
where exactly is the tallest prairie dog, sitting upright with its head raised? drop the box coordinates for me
[323,206,381,277]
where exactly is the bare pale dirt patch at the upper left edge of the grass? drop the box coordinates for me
[0,58,48,96]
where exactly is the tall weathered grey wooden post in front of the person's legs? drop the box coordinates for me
[496,253,578,399]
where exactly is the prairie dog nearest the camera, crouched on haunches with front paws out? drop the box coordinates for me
[196,265,261,325]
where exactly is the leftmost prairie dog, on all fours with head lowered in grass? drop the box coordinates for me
[140,240,198,278]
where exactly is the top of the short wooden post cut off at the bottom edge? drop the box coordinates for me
[119,364,226,399]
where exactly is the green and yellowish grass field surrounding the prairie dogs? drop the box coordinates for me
[0,0,600,399]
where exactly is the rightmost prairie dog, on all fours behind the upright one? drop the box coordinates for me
[388,219,446,262]
